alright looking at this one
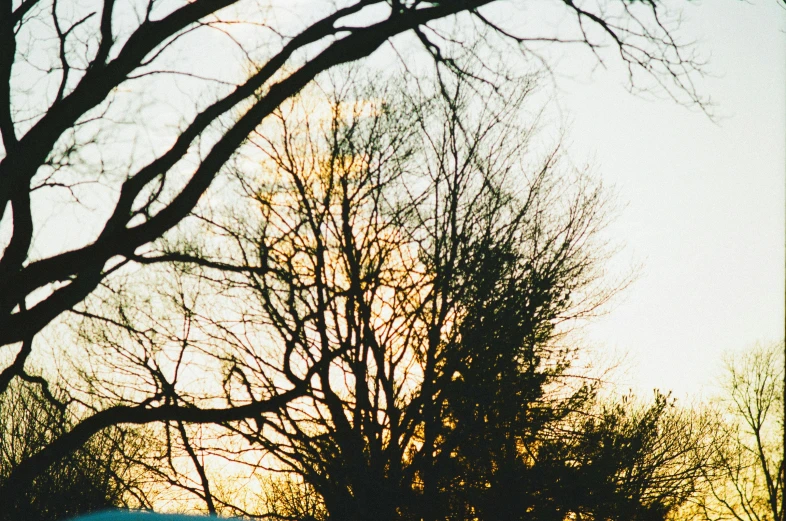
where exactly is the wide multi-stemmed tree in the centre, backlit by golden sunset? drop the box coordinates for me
[130,71,706,519]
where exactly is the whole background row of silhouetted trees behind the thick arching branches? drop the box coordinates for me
[0,76,784,521]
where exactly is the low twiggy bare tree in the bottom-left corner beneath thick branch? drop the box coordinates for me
[0,380,145,521]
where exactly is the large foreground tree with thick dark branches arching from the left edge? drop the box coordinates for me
[0,0,698,496]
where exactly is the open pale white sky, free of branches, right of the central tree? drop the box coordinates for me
[560,0,786,396]
